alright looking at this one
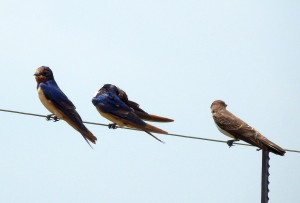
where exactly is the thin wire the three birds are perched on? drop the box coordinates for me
[0,109,300,153]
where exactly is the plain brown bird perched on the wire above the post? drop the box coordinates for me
[210,100,285,156]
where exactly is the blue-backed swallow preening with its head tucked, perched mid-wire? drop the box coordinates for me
[92,84,174,142]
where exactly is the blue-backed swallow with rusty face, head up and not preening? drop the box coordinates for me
[34,66,97,146]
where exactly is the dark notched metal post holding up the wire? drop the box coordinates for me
[261,149,270,203]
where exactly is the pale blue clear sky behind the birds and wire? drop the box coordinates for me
[0,0,300,203]
